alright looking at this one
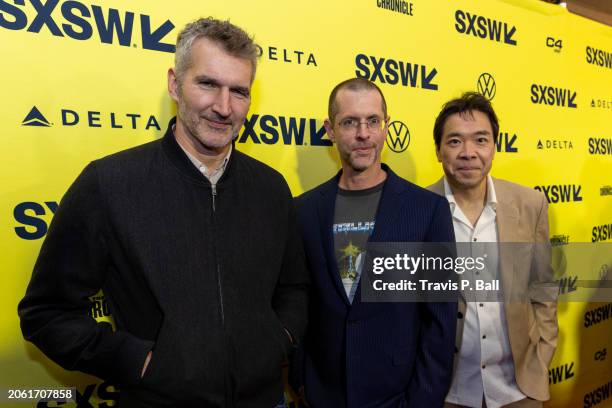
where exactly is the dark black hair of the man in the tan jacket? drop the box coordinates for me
[434,92,499,150]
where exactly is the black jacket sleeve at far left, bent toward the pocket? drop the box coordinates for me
[18,163,153,384]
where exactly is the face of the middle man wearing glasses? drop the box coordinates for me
[325,89,387,172]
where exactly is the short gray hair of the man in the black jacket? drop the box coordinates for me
[174,17,260,82]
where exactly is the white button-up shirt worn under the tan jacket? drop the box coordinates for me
[444,176,527,408]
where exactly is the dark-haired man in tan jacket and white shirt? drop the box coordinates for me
[429,93,558,408]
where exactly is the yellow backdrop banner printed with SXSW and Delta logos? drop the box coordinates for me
[0,0,612,407]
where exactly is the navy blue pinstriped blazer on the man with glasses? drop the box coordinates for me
[292,164,457,408]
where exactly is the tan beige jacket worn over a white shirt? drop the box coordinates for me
[428,178,558,401]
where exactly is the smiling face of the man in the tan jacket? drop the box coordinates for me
[436,111,495,190]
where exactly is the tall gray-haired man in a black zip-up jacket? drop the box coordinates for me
[19,18,308,407]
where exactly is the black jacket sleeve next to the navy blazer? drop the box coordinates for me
[272,187,309,354]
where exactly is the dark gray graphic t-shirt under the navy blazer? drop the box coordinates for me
[333,182,384,303]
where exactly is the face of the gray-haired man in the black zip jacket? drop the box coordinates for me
[168,38,253,151]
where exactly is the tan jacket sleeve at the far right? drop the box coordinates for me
[530,195,559,365]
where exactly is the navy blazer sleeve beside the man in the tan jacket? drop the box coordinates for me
[406,198,457,408]
